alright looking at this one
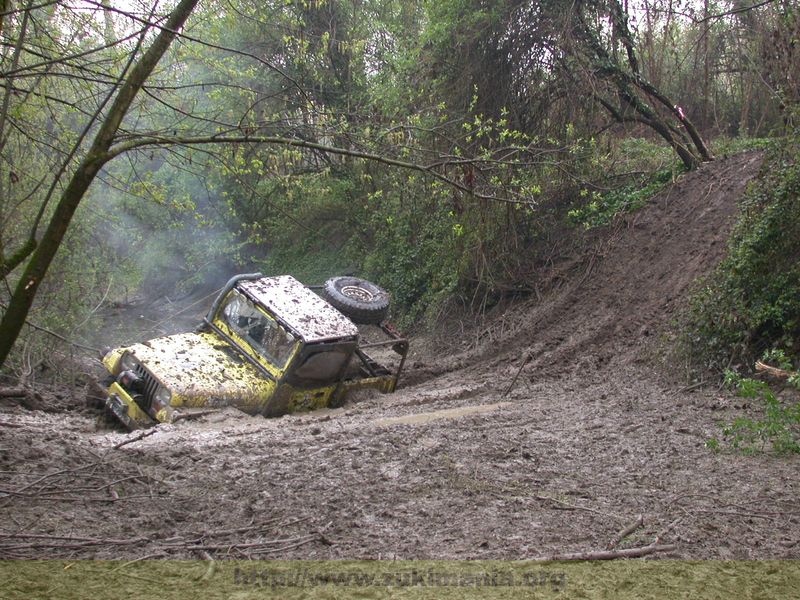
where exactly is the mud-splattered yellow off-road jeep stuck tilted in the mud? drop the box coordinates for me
[102,273,408,429]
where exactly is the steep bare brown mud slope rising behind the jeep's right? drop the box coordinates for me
[438,152,762,378]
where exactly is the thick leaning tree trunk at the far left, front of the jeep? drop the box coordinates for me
[0,0,199,367]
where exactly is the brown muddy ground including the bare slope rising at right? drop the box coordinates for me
[0,153,800,559]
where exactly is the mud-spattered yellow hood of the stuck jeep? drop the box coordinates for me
[120,333,273,406]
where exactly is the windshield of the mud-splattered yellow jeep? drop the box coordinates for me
[220,290,297,368]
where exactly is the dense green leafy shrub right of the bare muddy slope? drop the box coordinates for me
[684,138,800,372]
